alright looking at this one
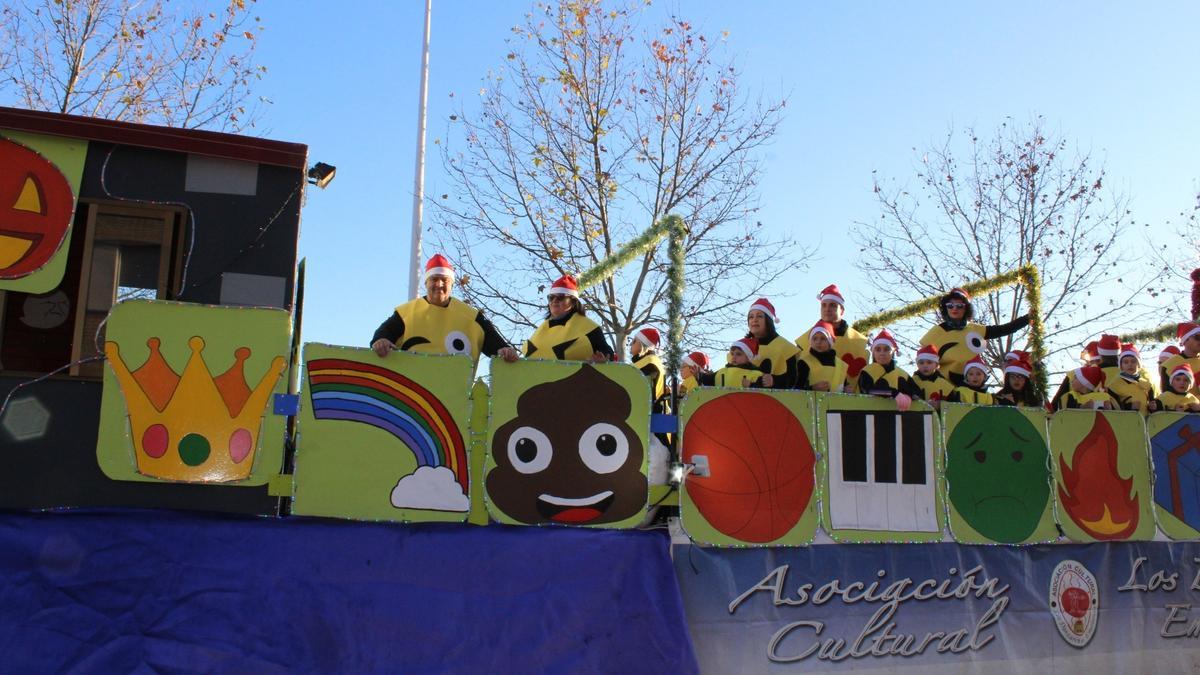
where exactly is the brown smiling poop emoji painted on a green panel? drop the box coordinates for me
[486,365,647,525]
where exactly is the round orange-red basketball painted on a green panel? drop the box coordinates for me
[683,392,816,544]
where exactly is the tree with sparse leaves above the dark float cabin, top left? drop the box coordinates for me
[0,0,266,131]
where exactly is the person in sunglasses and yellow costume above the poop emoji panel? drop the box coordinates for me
[524,274,613,363]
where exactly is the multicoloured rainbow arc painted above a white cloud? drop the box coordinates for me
[307,359,467,494]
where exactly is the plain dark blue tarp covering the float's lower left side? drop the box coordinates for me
[0,512,696,674]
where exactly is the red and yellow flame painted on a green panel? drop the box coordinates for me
[1058,413,1138,540]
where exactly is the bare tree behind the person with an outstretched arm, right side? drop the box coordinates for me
[853,118,1163,372]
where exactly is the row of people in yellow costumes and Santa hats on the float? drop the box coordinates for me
[371,255,1200,414]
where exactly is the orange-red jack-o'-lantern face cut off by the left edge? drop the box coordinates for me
[0,138,74,279]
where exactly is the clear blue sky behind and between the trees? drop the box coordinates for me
[257,0,1200,362]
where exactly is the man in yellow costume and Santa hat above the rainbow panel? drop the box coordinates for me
[371,253,517,363]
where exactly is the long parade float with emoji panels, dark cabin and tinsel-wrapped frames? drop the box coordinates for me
[0,108,1200,673]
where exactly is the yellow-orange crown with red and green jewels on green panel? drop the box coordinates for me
[104,336,287,483]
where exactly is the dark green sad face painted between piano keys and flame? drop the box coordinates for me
[946,407,1050,544]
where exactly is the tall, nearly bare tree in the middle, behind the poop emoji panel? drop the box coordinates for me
[434,0,803,352]
